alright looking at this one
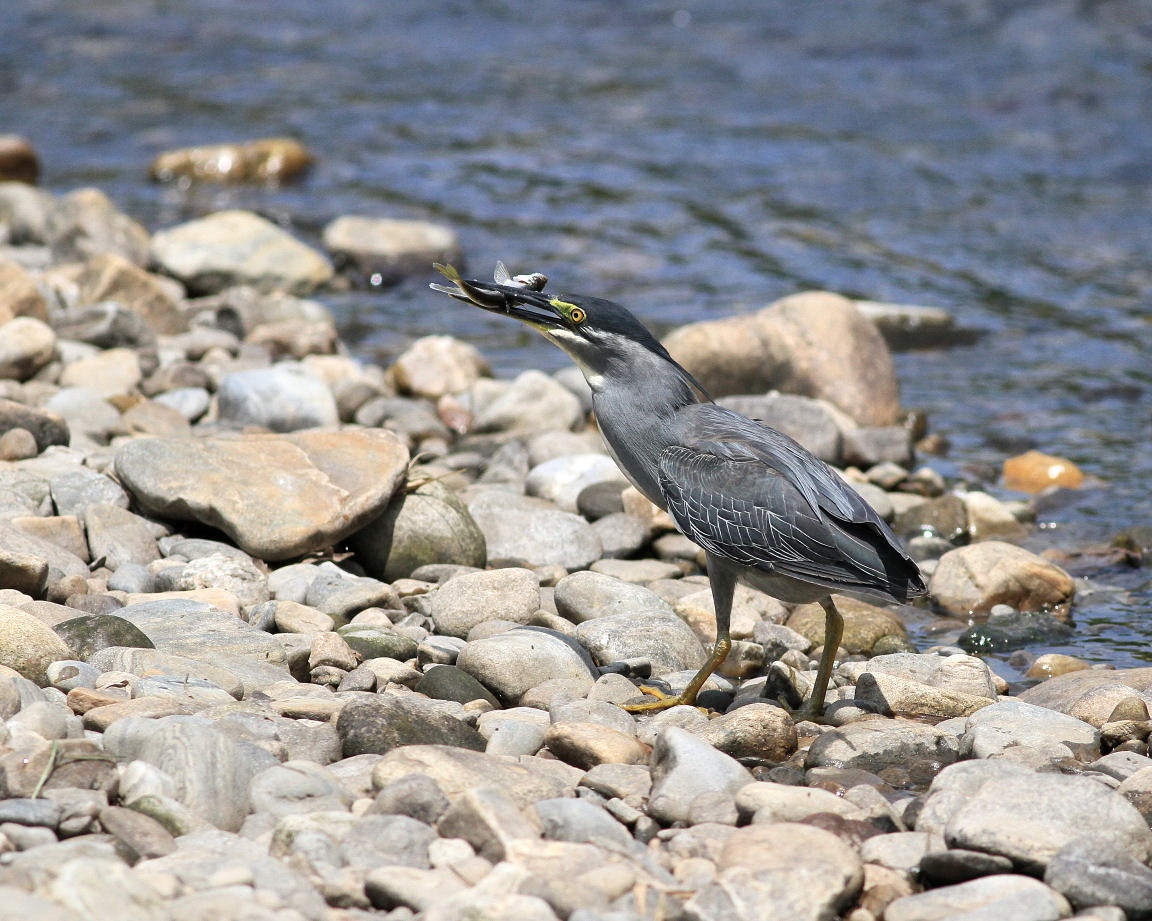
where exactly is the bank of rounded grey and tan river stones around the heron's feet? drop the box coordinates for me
[0,154,1152,921]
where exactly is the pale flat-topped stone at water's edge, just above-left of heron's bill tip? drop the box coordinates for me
[324,214,460,285]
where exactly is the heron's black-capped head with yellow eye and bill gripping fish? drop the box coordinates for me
[431,265,679,387]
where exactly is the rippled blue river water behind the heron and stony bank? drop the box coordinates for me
[9,0,1152,665]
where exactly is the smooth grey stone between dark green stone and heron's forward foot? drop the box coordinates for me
[456,627,594,703]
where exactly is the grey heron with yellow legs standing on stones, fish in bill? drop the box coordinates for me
[431,264,925,720]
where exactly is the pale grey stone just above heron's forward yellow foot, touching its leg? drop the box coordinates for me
[576,610,707,674]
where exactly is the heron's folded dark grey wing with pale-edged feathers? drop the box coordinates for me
[659,403,924,601]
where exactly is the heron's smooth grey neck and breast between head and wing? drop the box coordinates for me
[589,355,700,508]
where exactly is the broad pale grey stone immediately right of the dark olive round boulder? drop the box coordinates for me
[468,490,604,572]
